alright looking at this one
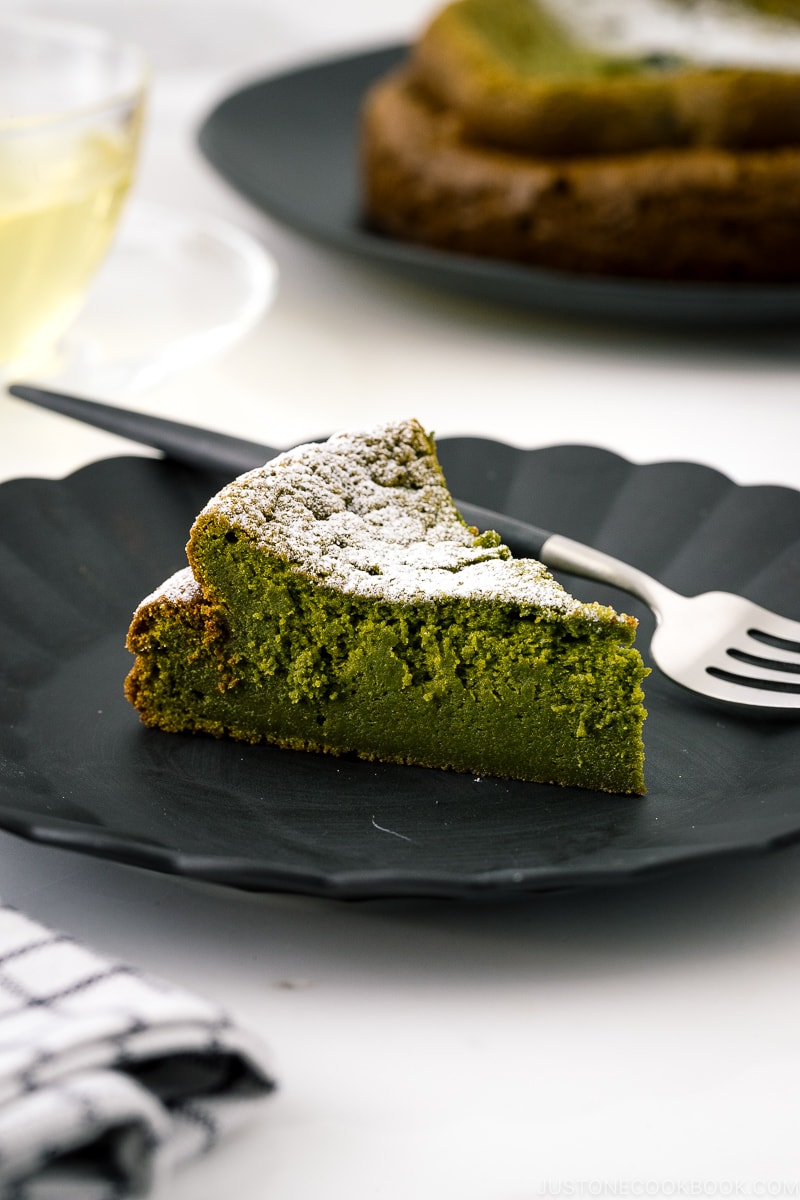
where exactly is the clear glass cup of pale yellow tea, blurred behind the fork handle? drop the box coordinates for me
[0,16,148,379]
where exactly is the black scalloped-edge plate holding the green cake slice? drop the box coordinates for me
[0,438,800,898]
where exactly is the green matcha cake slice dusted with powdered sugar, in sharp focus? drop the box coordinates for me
[125,420,646,793]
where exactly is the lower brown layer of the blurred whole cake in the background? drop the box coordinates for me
[362,71,800,283]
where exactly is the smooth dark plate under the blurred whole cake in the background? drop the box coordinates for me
[199,46,800,329]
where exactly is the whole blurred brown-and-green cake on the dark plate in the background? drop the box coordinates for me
[361,0,800,283]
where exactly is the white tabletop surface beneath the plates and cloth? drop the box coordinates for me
[0,0,800,1200]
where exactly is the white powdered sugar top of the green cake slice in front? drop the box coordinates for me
[189,420,608,618]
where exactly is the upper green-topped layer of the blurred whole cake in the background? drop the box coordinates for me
[409,0,800,157]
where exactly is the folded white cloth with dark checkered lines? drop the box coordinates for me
[0,905,273,1200]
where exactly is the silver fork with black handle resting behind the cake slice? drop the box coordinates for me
[8,384,800,715]
